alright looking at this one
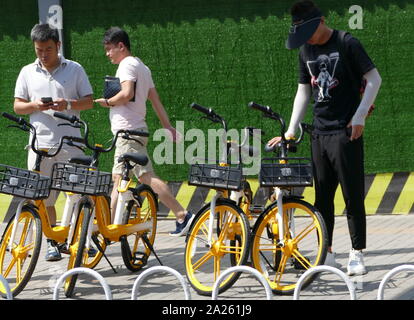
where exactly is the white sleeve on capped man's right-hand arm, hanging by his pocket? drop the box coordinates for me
[352,68,382,126]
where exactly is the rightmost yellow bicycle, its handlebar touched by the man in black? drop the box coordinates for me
[249,102,328,294]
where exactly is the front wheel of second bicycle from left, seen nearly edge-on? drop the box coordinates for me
[64,200,92,298]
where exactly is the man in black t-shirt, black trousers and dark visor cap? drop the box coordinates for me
[268,1,381,275]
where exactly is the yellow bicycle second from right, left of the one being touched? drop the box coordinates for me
[184,103,266,295]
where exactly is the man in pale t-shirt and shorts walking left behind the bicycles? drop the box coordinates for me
[95,27,194,236]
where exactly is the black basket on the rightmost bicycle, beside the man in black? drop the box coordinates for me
[259,158,313,187]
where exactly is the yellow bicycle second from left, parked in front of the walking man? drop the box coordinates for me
[52,113,158,296]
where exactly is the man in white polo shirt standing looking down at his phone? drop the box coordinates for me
[14,24,93,261]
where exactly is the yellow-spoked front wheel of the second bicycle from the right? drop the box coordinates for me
[184,199,250,295]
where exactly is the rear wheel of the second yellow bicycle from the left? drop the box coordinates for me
[121,184,157,272]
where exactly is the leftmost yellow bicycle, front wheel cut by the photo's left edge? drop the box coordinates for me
[0,113,107,296]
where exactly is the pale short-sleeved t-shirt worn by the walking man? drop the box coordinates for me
[109,56,155,134]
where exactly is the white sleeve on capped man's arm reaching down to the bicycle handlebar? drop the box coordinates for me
[285,83,311,137]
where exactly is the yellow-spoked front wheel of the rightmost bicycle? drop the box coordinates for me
[251,199,328,294]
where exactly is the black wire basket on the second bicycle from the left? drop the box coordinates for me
[51,162,112,196]
